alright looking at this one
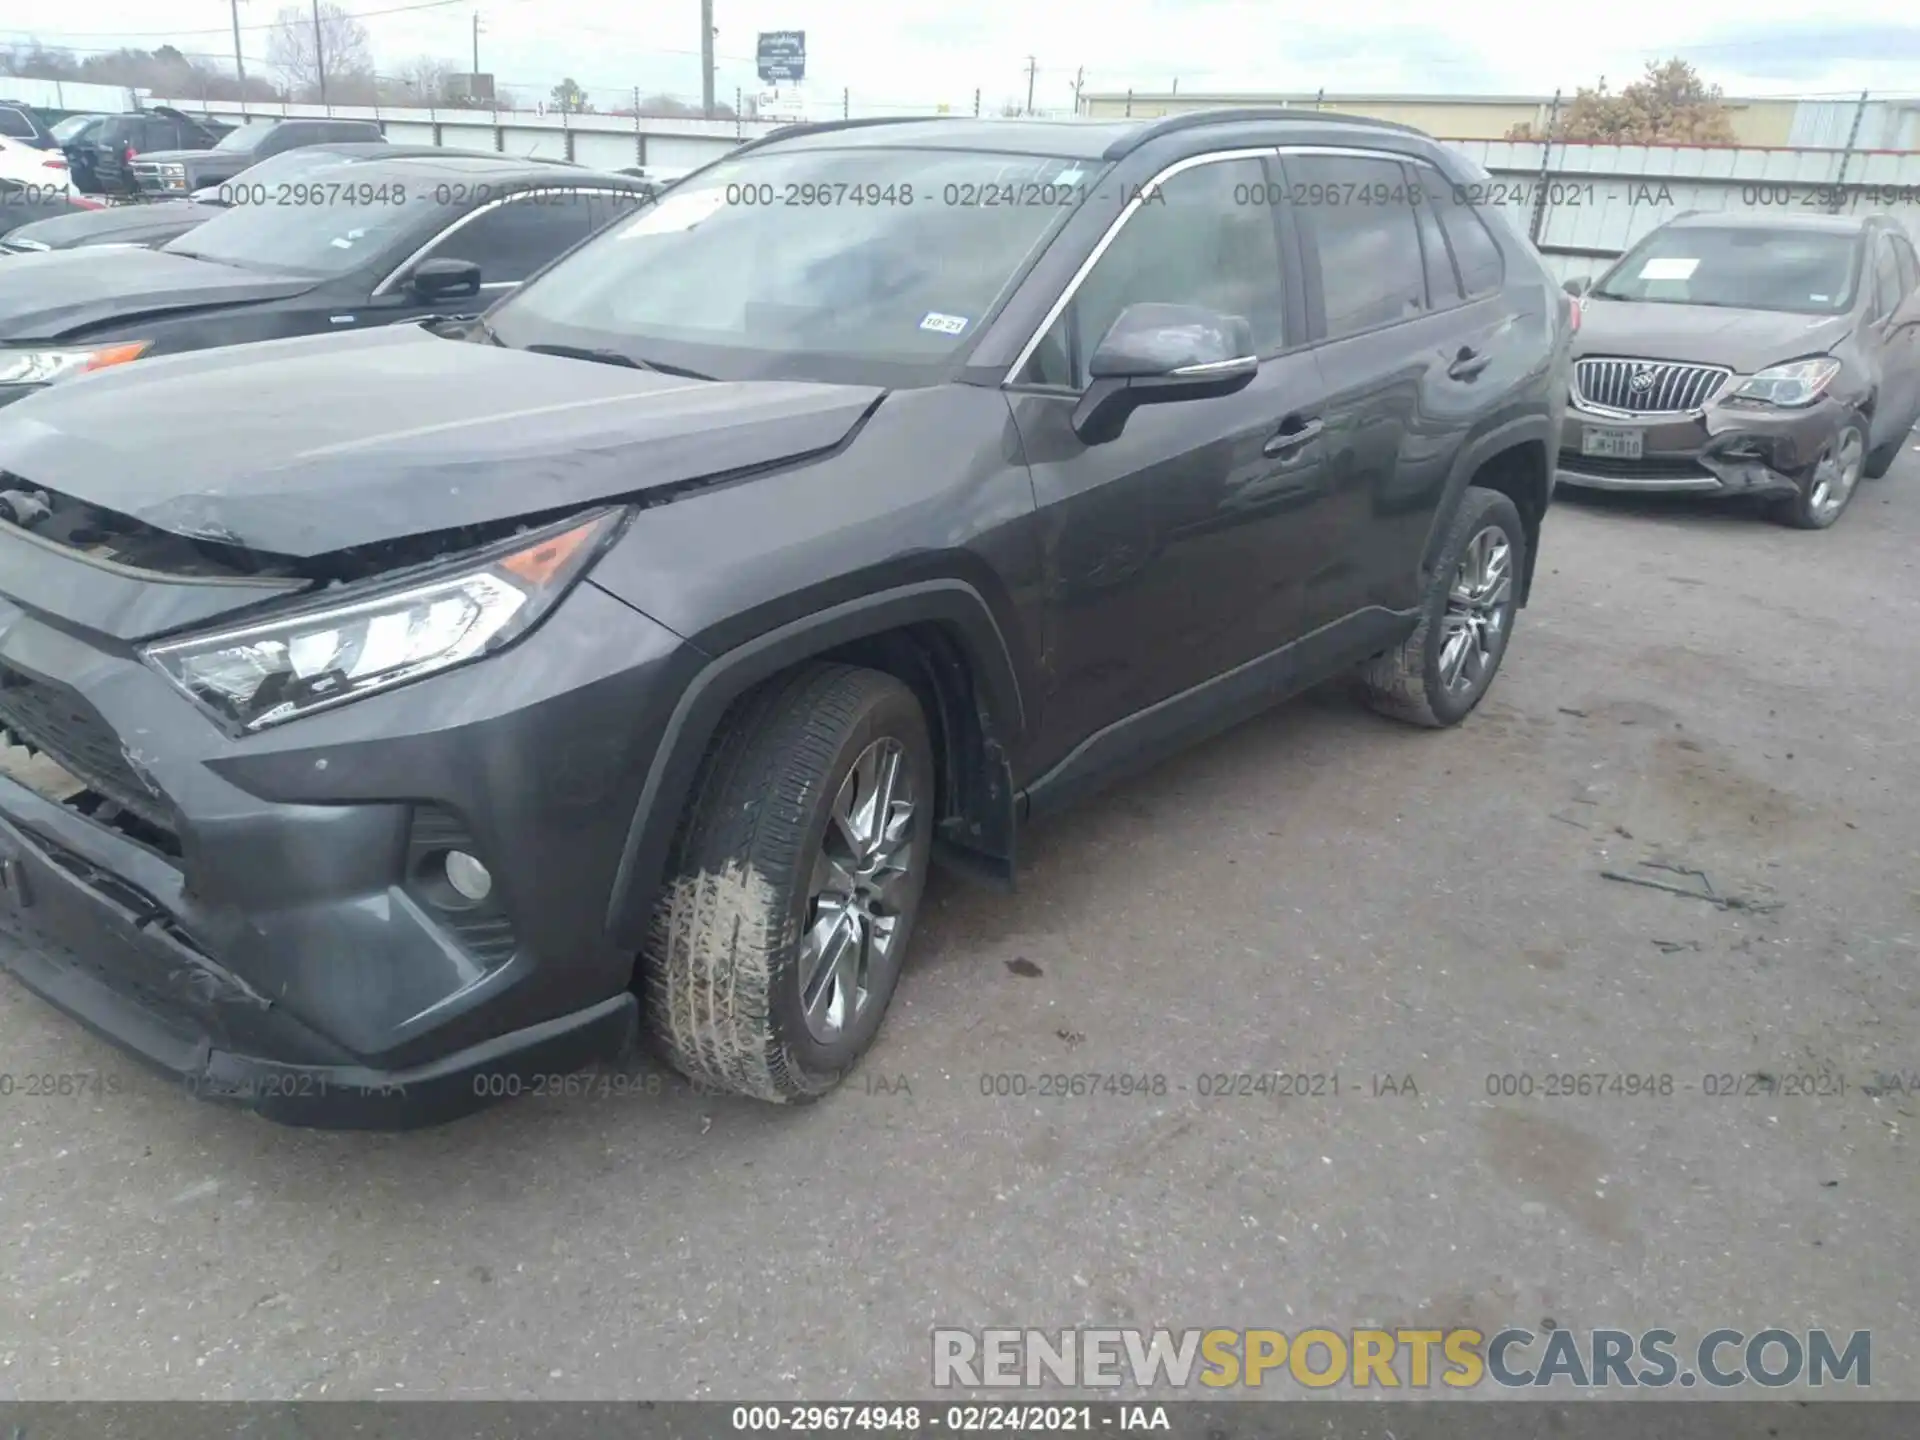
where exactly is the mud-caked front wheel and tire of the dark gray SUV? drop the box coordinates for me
[641,664,935,1104]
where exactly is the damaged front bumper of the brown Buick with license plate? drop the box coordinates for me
[1557,384,1853,495]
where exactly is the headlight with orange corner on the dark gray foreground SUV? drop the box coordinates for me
[146,511,626,732]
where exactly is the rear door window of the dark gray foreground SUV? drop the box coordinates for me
[1286,156,1427,340]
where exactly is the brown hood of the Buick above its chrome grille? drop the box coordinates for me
[1574,296,1853,374]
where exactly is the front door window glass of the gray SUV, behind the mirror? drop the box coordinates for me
[1021,157,1284,390]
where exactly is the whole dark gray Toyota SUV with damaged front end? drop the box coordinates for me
[0,111,1572,1123]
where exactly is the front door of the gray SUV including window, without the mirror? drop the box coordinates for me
[1008,152,1327,770]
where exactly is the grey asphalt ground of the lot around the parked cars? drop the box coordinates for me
[0,438,1920,1400]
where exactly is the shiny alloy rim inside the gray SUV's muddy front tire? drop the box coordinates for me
[799,737,920,1044]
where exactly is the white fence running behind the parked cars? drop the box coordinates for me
[150,100,1920,280]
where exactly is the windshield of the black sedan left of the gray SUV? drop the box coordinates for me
[163,165,453,276]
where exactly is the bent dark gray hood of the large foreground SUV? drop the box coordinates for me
[0,326,885,557]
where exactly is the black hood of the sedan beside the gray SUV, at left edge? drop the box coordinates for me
[0,246,315,346]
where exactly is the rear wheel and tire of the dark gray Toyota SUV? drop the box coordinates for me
[1359,486,1526,730]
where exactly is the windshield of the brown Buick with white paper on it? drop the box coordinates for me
[1594,225,1859,315]
